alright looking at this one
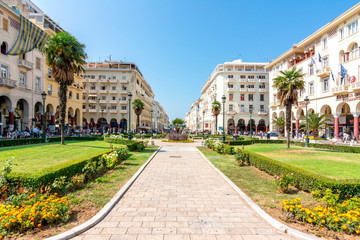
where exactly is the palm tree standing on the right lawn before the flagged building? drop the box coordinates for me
[273,67,305,148]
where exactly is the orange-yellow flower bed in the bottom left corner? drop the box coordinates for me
[0,193,71,239]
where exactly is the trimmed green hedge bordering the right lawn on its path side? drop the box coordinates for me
[238,149,360,198]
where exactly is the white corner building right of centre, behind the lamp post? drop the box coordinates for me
[187,59,269,133]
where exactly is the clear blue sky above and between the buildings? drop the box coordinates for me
[33,0,359,121]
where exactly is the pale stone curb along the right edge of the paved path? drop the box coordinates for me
[196,148,321,240]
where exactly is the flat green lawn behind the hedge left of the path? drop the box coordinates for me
[0,141,126,174]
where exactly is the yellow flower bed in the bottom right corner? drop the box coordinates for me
[282,198,360,235]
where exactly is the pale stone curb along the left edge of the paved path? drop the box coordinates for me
[45,147,161,240]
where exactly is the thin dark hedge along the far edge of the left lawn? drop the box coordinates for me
[0,136,103,147]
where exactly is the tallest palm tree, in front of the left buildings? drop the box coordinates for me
[41,32,86,144]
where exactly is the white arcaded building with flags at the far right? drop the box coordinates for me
[265,4,360,138]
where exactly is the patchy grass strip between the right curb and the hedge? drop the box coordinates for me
[198,147,314,209]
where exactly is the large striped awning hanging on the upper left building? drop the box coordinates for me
[6,15,49,55]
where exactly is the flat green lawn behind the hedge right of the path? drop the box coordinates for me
[245,144,360,179]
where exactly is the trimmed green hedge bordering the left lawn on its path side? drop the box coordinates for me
[8,149,113,191]
